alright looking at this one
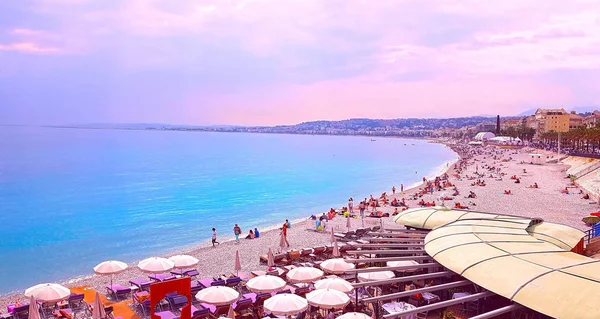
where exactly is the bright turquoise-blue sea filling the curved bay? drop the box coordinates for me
[0,127,457,293]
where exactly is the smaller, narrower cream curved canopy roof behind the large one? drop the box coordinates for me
[394,206,585,250]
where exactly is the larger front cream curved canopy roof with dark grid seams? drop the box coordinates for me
[425,219,600,319]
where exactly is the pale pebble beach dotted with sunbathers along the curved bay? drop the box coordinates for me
[0,144,598,316]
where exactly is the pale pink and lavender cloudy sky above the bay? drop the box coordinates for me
[0,0,600,125]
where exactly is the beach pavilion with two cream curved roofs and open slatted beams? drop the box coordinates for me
[338,207,600,319]
